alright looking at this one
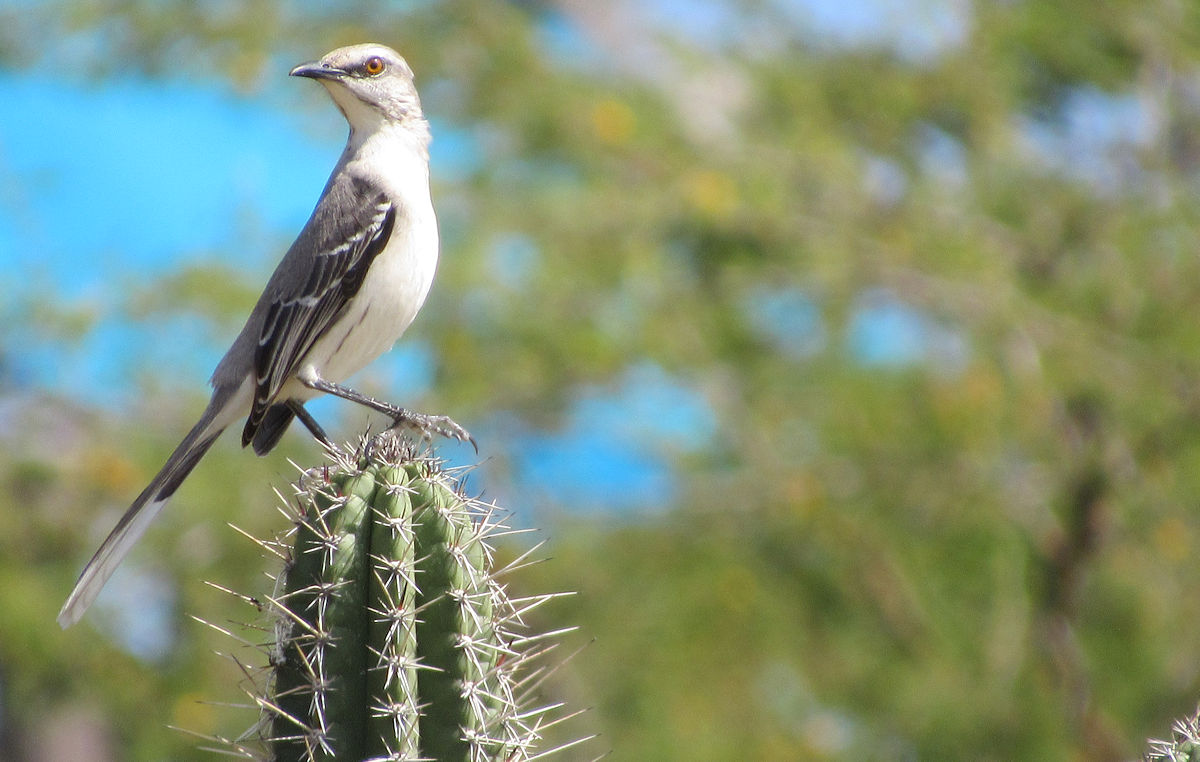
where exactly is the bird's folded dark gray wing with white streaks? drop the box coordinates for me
[241,178,396,445]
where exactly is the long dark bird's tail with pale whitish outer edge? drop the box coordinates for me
[59,403,228,629]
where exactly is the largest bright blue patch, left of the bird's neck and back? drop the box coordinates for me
[0,71,328,299]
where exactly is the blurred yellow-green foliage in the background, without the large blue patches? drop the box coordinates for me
[0,0,1200,761]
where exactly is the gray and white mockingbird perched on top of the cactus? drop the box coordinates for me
[59,44,474,628]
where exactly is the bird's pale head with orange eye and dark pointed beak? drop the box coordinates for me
[292,42,424,132]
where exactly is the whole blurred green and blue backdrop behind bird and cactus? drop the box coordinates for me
[0,0,1200,761]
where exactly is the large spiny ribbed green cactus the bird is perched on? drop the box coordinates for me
[202,434,580,762]
